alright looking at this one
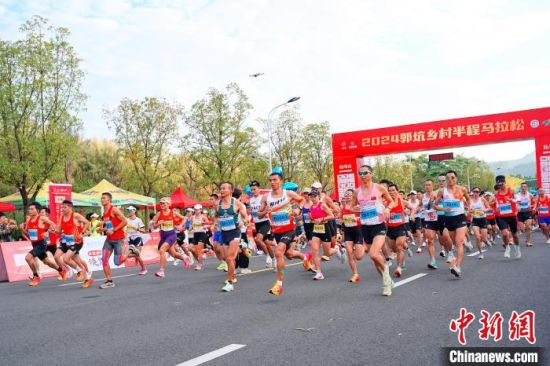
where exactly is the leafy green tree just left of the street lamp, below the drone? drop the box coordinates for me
[181,83,259,188]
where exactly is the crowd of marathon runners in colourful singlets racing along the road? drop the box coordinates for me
[22,165,550,296]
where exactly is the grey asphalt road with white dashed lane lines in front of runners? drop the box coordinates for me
[0,233,550,365]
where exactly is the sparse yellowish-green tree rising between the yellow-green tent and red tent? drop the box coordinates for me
[104,97,183,196]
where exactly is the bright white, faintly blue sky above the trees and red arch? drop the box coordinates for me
[0,0,550,161]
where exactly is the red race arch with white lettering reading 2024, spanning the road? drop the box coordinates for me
[332,107,550,198]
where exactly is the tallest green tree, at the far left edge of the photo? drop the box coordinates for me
[0,16,86,207]
